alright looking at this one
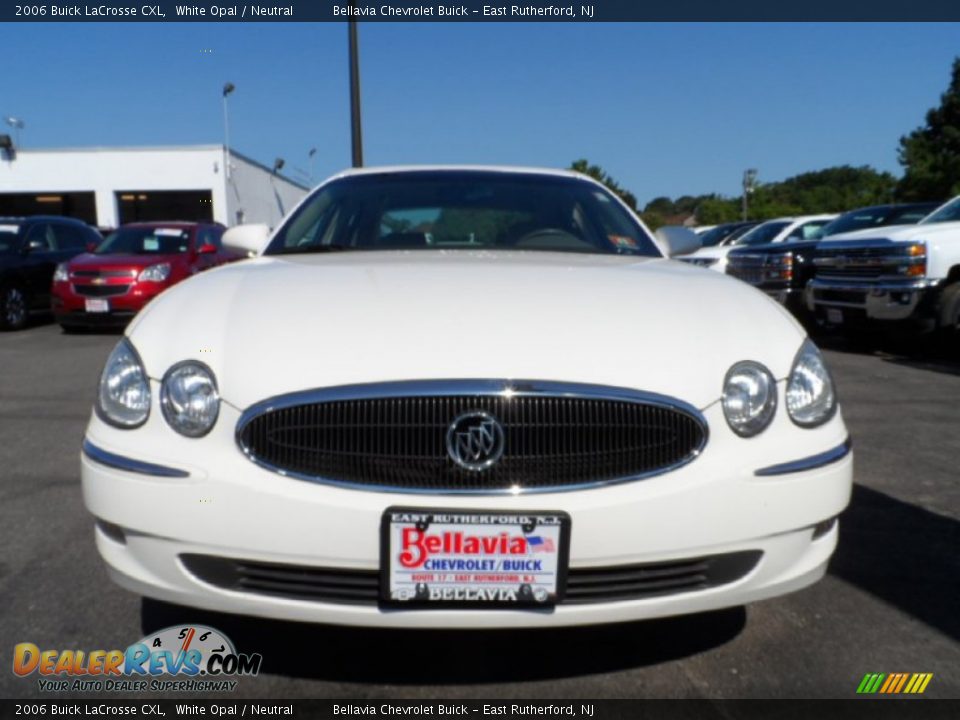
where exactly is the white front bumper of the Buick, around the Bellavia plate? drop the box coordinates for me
[81,405,853,628]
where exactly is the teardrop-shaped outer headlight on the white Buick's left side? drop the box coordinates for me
[96,338,150,429]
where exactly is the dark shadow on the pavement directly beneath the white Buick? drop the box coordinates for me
[141,599,746,685]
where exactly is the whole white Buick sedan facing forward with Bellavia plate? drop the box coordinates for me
[82,168,852,627]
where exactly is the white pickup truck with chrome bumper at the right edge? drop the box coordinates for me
[805,197,960,333]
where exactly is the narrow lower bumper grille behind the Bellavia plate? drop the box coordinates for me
[180,550,763,605]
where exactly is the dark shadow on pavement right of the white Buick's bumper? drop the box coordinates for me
[829,485,960,640]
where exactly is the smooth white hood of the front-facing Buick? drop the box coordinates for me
[127,251,804,409]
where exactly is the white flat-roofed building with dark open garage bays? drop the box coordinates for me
[0,145,308,228]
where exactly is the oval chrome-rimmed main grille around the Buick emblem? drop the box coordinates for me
[237,381,707,494]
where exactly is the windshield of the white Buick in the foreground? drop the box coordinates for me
[266,171,660,257]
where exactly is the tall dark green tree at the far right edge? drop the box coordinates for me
[897,57,960,200]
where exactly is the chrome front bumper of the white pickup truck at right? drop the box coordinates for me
[804,278,939,320]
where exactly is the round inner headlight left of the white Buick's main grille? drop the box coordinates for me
[160,360,220,437]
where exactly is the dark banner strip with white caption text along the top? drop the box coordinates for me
[0,0,960,23]
